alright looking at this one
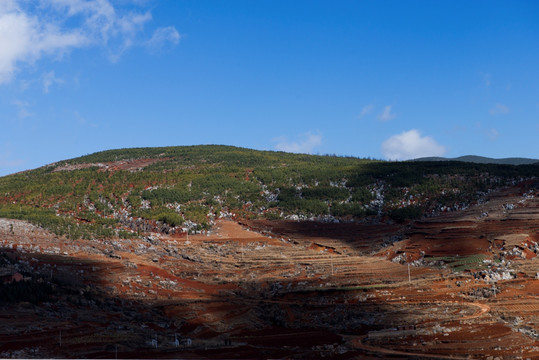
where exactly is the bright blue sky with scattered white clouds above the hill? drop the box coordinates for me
[0,0,539,175]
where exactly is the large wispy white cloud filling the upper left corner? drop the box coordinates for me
[0,0,179,84]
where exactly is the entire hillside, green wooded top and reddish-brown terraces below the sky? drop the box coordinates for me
[0,146,539,359]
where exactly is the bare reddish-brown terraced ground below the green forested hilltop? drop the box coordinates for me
[0,184,539,359]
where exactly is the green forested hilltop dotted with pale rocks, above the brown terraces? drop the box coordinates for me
[0,145,539,239]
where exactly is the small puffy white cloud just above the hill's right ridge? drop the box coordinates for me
[382,129,446,160]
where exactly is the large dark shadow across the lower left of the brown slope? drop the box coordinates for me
[0,243,432,358]
